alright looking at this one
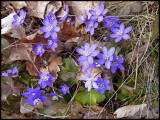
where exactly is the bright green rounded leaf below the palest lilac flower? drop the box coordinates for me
[75,88,105,105]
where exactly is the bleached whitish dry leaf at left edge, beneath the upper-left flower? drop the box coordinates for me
[1,13,26,39]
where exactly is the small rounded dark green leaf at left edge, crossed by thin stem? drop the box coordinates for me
[1,38,11,57]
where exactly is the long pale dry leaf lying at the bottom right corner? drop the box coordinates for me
[114,104,147,118]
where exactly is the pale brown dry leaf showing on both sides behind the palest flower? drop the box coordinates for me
[76,67,102,80]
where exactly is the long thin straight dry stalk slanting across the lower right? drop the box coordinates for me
[97,43,158,118]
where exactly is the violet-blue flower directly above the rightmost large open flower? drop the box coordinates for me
[104,15,119,29]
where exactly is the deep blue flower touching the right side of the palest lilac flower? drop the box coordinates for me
[94,77,111,94]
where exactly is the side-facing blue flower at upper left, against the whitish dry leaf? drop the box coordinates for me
[12,10,26,28]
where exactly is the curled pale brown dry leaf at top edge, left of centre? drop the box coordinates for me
[45,1,62,16]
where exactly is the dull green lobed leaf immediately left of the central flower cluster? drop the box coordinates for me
[59,58,80,75]
